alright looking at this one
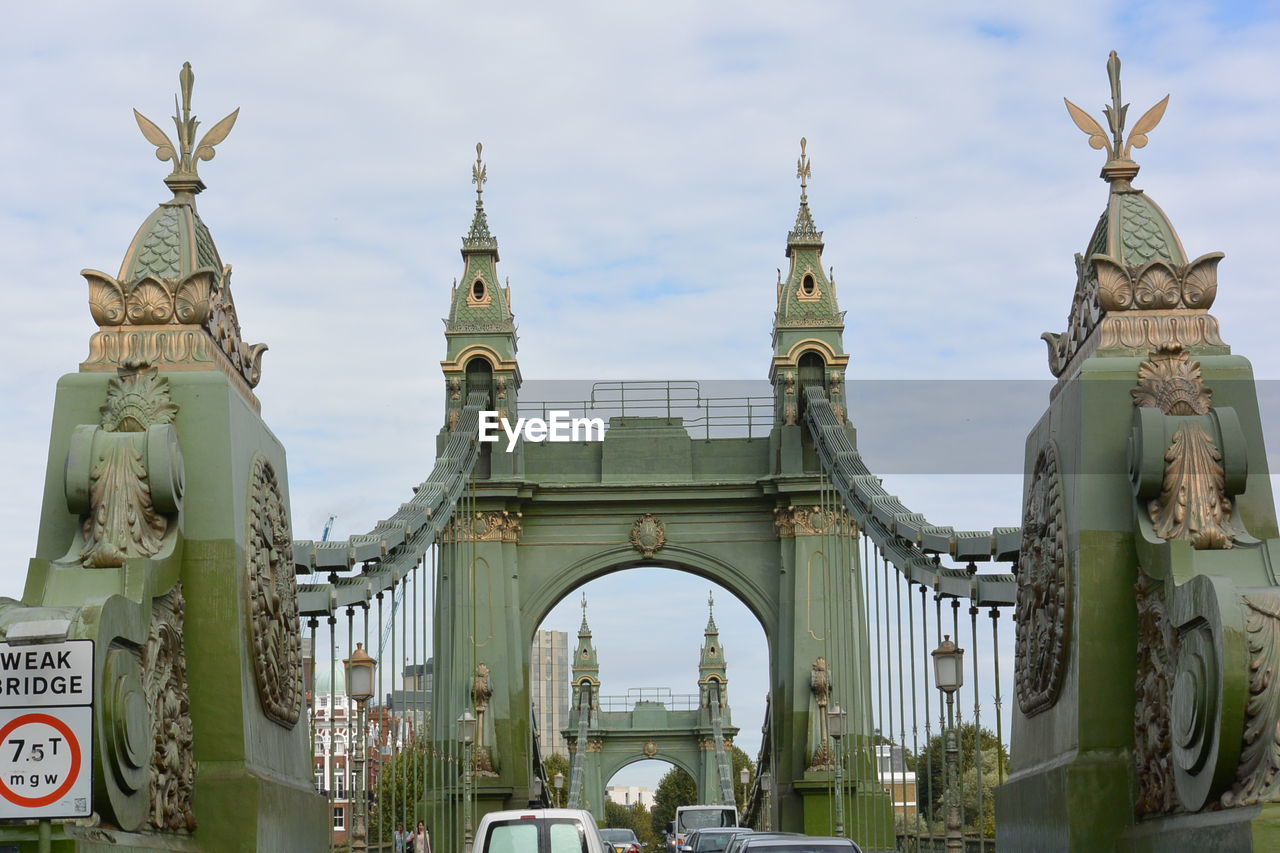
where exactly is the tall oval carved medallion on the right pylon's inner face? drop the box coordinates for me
[1014,442,1071,716]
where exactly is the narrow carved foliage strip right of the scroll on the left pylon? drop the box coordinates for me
[143,584,196,833]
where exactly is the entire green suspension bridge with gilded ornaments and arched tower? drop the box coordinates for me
[0,54,1280,853]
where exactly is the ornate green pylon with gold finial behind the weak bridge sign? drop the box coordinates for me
[0,64,322,852]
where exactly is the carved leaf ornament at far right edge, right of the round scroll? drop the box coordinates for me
[1221,589,1280,807]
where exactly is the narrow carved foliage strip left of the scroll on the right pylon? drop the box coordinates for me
[1133,569,1178,816]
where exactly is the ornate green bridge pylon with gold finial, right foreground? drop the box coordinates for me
[996,51,1280,852]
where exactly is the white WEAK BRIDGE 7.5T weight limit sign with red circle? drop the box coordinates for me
[0,640,93,820]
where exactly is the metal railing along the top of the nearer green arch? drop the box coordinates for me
[516,379,774,439]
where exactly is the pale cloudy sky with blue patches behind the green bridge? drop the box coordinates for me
[0,0,1280,783]
